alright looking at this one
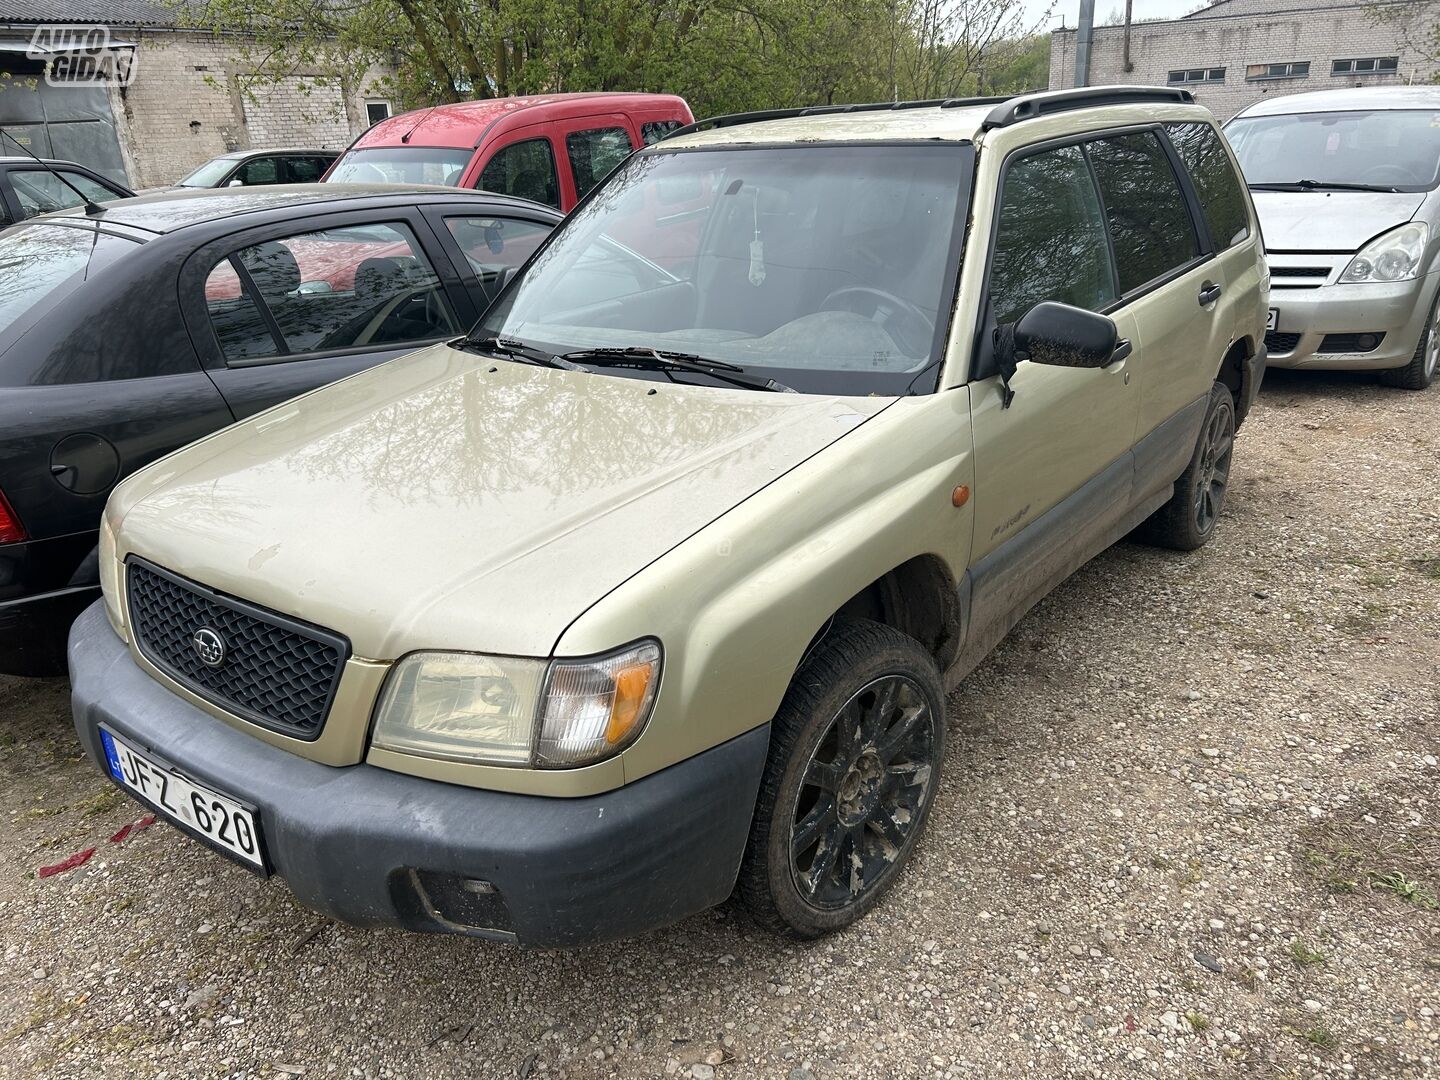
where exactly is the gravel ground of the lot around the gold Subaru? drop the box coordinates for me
[0,373,1440,1080]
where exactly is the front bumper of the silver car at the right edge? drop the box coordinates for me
[1266,274,1440,372]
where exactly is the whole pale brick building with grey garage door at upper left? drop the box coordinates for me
[0,0,392,189]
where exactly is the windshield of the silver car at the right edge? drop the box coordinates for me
[1225,109,1440,192]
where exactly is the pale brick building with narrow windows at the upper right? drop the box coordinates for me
[1050,0,1440,120]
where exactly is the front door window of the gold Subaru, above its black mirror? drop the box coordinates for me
[991,147,1116,323]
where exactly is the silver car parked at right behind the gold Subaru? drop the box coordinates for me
[1225,86,1440,390]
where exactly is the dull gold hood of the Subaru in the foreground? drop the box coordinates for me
[108,346,891,660]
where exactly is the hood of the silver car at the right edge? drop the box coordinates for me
[1250,192,1426,252]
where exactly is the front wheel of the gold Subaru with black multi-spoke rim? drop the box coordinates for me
[736,619,945,937]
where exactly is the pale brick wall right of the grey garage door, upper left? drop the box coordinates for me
[112,27,384,189]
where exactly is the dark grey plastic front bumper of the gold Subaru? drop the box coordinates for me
[69,603,769,948]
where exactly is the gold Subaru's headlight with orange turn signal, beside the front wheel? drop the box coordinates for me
[374,641,660,768]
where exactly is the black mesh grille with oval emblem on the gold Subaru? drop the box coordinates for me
[125,556,350,739]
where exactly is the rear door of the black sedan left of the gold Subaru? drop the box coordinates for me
[180,206,478,418]
